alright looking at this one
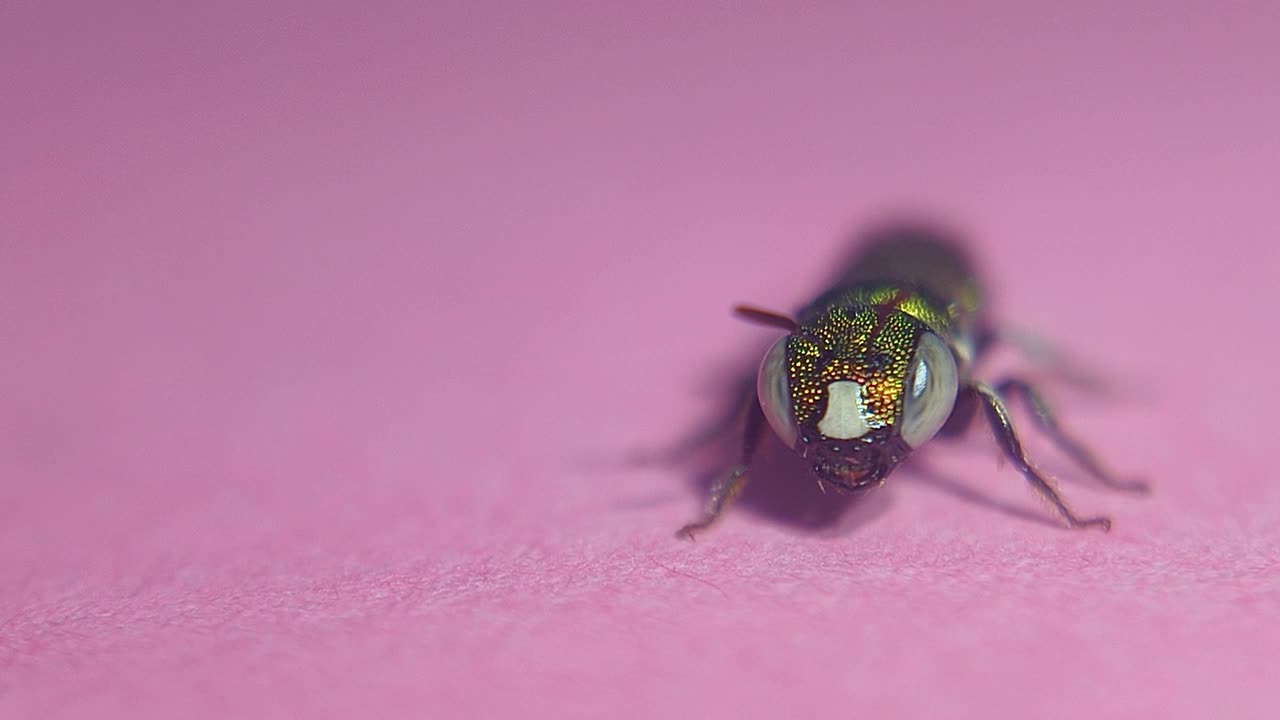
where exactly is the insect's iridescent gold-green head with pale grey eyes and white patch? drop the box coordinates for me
[758,299,959,489]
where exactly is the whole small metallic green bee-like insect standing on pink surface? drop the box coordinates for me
[677,224,1146,538]
